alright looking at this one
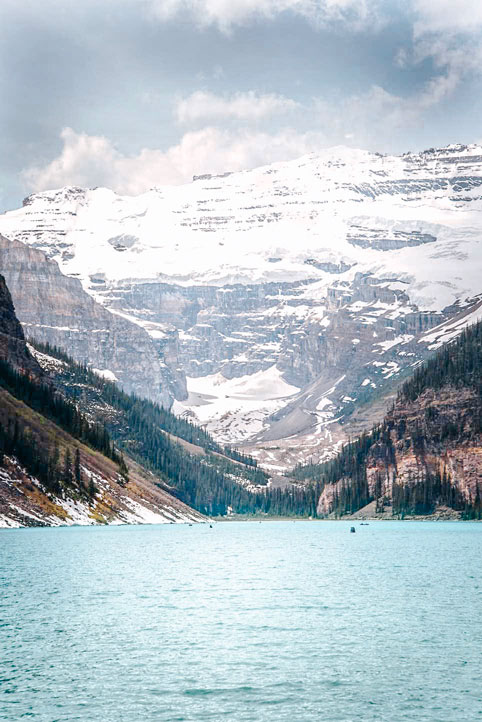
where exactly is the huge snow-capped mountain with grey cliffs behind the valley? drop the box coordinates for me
[0,145,482,467]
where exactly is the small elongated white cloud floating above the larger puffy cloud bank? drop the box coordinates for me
[175,91,298,123]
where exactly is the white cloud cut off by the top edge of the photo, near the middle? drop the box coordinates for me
[148,0,380,31]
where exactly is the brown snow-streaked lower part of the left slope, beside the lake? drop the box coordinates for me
[0,389,204,527]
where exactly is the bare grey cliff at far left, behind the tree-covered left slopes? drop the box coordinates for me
[0,236,183,405]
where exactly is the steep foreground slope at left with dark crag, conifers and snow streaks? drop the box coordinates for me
[0,276,203,527]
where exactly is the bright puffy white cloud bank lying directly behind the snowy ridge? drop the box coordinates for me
[22,127,326,195]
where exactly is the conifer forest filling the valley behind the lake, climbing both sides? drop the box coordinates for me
[21,323,482,518]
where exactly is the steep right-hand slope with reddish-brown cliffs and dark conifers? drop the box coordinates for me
[294,322,482,519]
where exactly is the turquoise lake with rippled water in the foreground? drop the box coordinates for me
[0,521,482,722]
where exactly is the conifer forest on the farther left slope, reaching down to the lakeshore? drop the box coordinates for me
[32,341,324,516]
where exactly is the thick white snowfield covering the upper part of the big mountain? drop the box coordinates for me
[0,145,482,310]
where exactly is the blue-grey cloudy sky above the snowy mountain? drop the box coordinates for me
[0,0,482,211]
